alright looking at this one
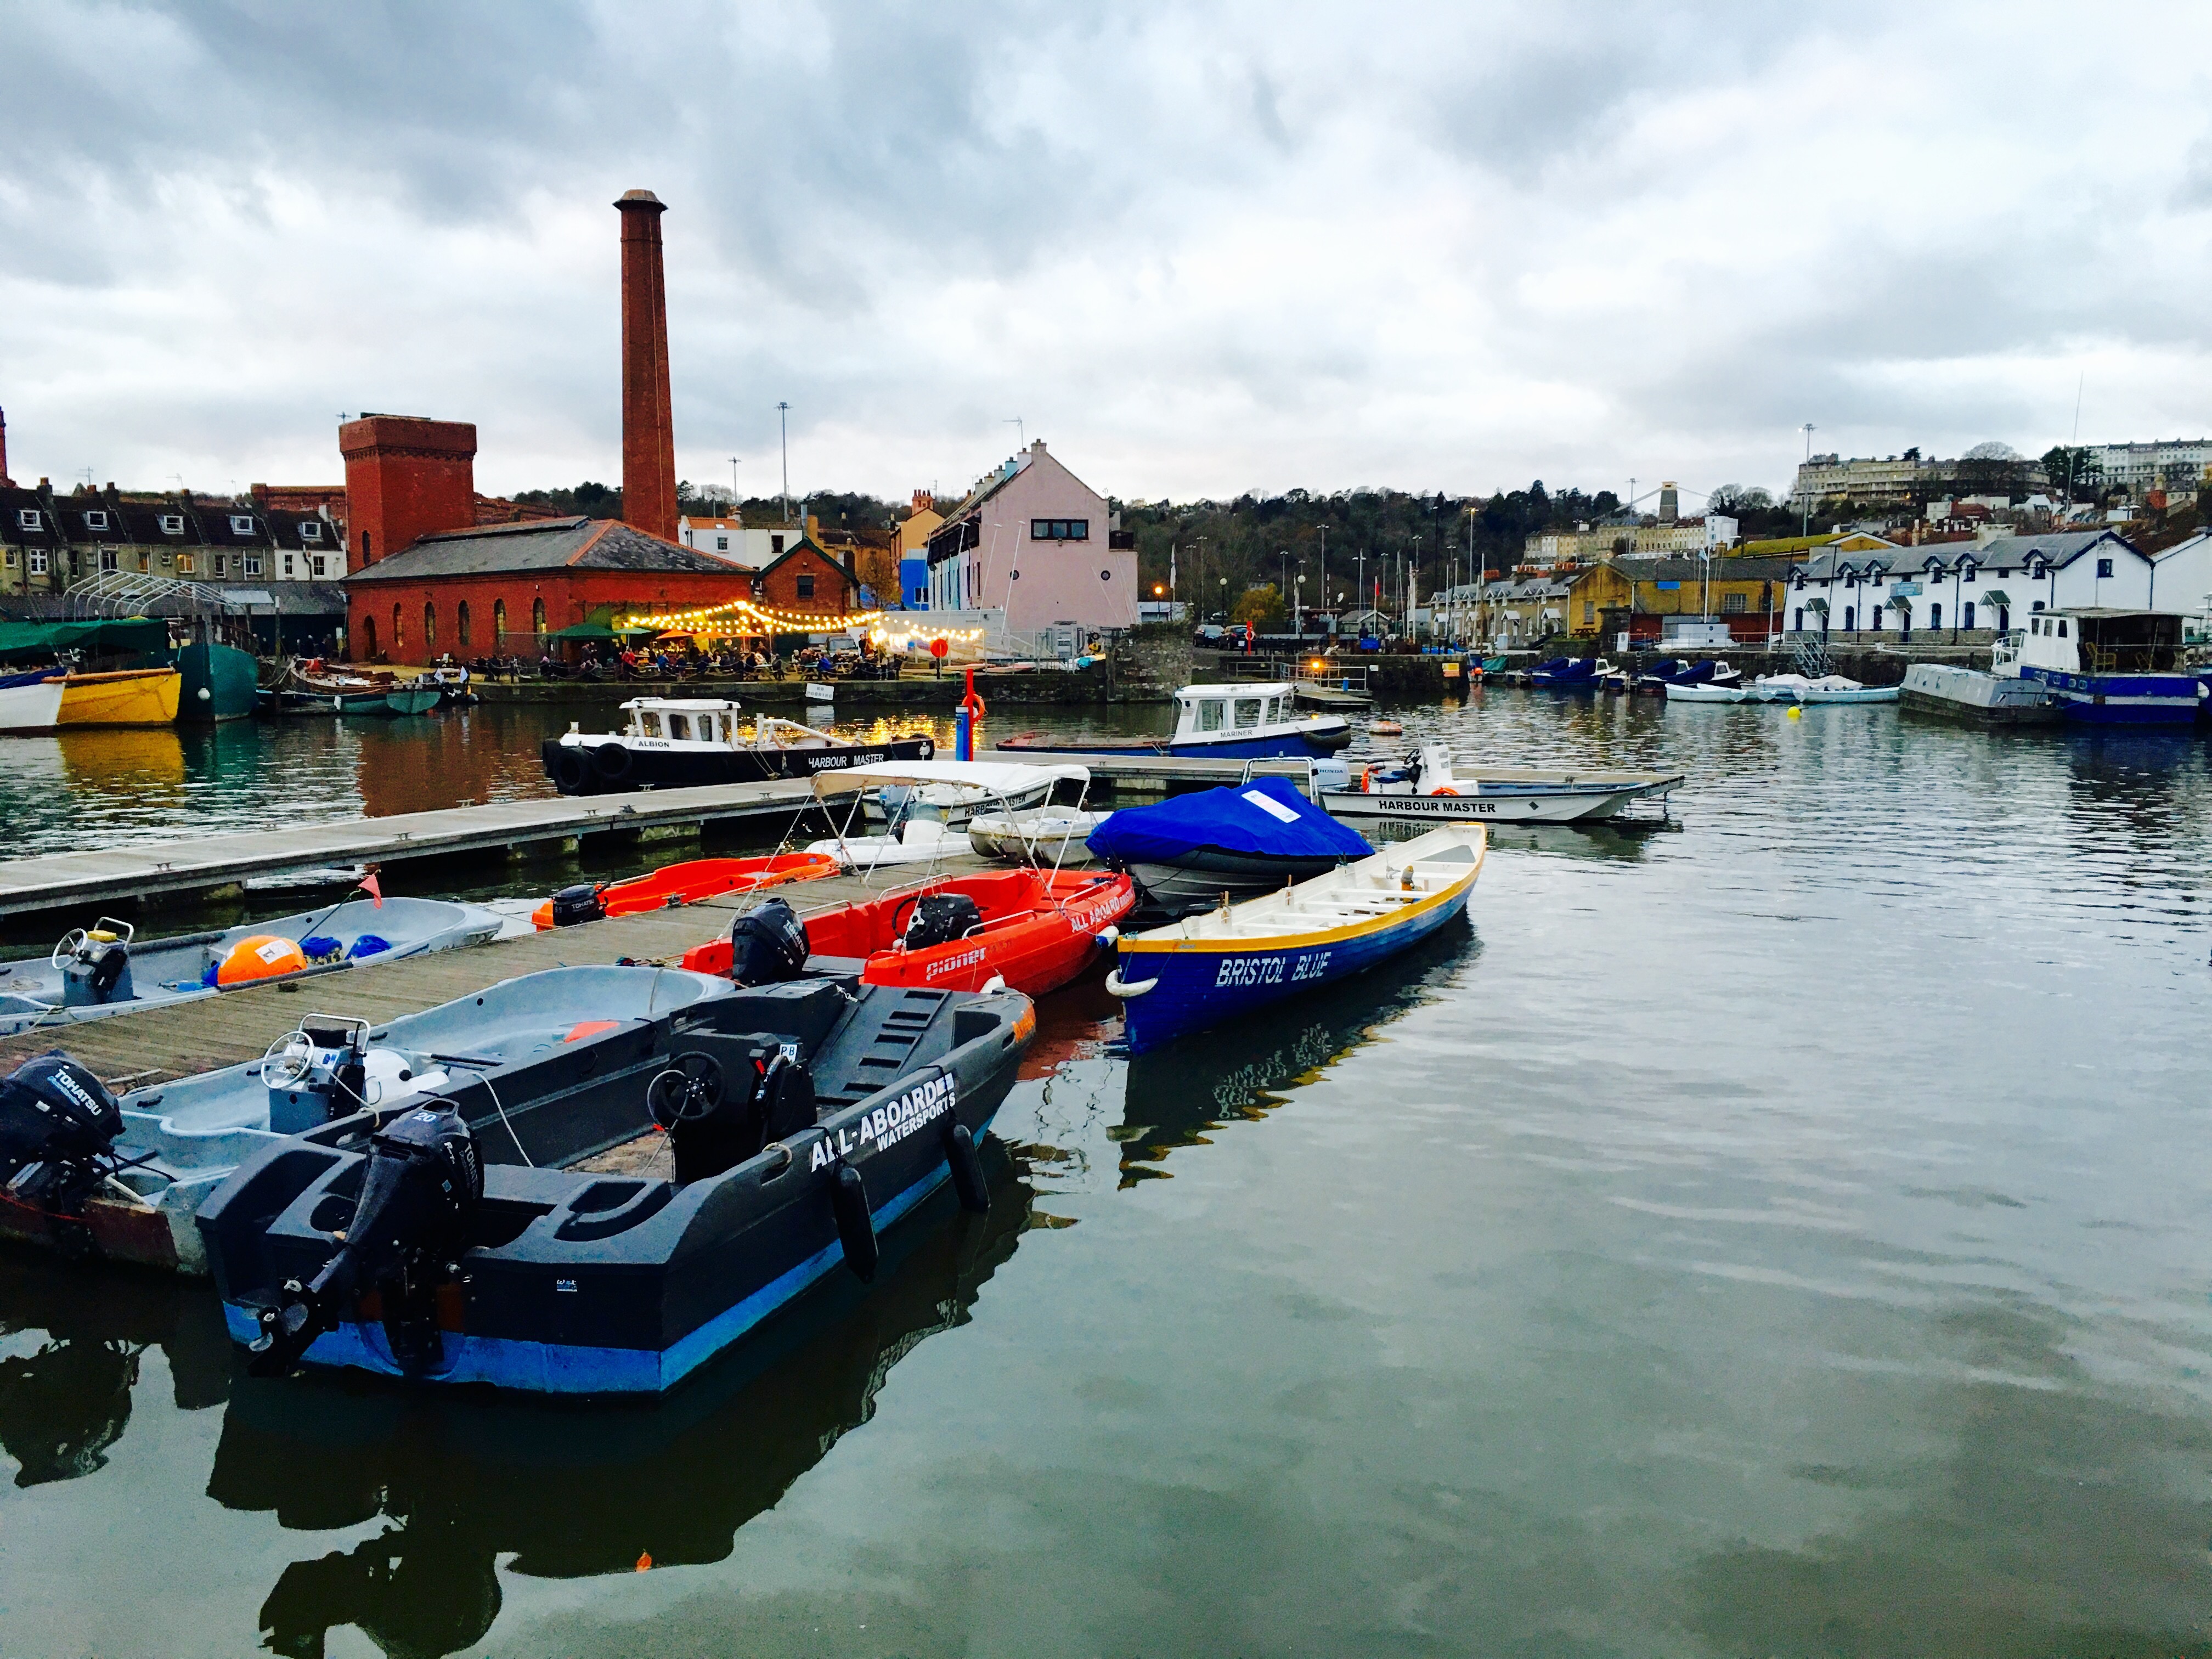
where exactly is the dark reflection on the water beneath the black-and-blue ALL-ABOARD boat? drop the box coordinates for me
[208,1153,1031,1659]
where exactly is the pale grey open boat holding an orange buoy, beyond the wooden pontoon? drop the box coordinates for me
[0,898,504,1035]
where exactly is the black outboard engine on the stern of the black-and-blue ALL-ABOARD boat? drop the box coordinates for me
[248,1102,484,1376]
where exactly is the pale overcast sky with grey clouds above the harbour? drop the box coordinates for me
[0,0,2212,498]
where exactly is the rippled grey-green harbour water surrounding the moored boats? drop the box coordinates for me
[0,692,2212,1657]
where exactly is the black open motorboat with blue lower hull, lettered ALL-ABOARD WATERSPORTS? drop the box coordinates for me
[199,980,1037,1396]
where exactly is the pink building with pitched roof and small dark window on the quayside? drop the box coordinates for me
[929,438,1137,633]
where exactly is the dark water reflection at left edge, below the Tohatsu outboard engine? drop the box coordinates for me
[0,1250,230,1487]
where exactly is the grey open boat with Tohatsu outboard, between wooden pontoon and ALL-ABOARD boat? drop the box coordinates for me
[0,967,735,1274]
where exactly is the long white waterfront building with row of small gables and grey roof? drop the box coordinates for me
[1783,531,2150,637]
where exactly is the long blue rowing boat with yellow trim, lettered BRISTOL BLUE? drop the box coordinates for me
[1106,825,1489,1055]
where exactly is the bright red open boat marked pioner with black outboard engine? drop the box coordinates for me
[684,870,1137,997]
